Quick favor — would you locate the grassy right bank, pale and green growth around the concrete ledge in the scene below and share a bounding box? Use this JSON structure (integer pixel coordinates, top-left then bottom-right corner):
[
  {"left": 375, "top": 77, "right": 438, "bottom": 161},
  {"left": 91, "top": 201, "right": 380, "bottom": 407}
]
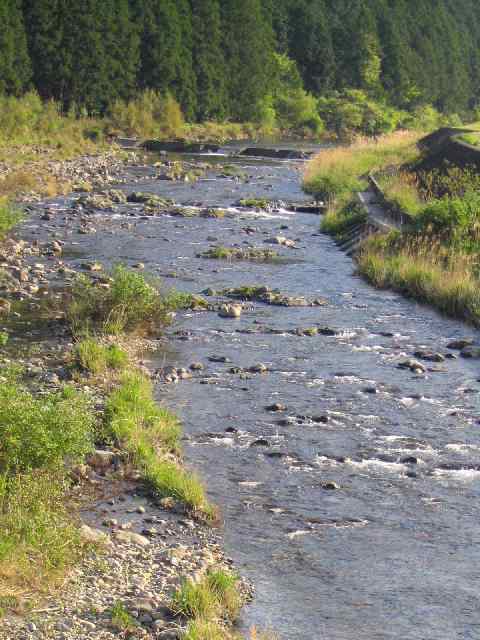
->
[{"left": 305, "top": 127, "right": 480, "bottom": 325}]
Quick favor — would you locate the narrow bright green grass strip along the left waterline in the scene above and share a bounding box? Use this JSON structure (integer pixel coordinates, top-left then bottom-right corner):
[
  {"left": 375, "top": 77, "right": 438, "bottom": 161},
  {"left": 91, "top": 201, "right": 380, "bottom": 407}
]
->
[{"left": 105, "top": 373, "right": 215, "bottom": 518}]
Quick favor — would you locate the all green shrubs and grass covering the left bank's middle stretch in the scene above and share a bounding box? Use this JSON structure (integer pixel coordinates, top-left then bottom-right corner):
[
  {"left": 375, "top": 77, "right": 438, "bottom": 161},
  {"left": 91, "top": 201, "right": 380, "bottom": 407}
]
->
[{"left": 0, "top": 267, "right": 215, "bottom": 613}]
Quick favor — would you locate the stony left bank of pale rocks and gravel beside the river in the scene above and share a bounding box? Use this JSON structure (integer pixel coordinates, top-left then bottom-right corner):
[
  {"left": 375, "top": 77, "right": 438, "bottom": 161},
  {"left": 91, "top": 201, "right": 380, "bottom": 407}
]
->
[{"left": 0, "top": 152, "right": 266, "bottom": 640}]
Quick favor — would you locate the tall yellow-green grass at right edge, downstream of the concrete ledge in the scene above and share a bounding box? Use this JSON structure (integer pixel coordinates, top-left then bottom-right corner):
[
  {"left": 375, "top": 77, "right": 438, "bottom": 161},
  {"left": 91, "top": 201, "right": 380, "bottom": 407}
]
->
[{"left": 358, "top": 236, "right": 480, "bottom": 326}]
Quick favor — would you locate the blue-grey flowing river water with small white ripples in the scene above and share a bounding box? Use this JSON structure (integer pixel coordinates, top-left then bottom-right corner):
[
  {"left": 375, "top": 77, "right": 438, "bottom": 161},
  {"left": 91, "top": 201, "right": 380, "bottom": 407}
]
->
[{"left": 28, "top": 146, "right": 480, "bottom": 640}]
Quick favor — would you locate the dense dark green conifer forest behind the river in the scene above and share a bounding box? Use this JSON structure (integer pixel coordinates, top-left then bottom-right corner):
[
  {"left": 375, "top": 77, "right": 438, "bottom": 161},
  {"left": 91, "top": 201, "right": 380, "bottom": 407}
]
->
[{"left": 0, "top": 0, "right": 480, "bottom": 120}]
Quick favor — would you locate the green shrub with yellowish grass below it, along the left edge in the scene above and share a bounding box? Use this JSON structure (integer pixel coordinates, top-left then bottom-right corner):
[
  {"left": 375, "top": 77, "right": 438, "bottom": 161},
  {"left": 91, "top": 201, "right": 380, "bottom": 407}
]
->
[{"left": 0, "top": 370, "right": 95, "bottom": 598}]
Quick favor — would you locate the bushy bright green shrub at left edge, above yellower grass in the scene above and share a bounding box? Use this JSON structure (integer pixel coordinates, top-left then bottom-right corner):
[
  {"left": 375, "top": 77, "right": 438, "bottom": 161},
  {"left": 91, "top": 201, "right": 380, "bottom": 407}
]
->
[{"left": 0, "top": 380, "right": 94, "bottom": 474}]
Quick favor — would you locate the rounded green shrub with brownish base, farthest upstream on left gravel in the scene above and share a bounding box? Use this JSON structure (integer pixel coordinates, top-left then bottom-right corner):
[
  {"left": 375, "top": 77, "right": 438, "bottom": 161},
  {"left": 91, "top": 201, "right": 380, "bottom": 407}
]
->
[{"left": 67, "top": 266, "right": 171, "bottom": 335}]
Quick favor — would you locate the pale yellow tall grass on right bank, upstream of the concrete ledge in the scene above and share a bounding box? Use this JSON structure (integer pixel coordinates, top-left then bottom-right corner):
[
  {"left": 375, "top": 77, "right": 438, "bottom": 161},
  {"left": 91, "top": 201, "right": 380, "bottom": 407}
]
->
[{"left": 303, "top": 131, "right": 420, "bottom": 206}]
